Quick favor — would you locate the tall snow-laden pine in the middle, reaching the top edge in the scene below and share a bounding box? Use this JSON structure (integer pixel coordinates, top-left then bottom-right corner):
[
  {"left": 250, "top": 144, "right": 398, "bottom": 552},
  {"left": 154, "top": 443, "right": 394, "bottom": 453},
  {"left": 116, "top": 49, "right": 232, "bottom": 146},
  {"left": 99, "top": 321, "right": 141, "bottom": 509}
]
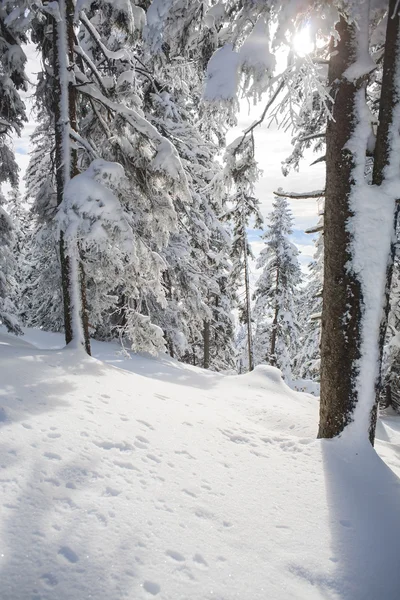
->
[{"left": 138, "top": 1, "right": 234, "bottom": 369}]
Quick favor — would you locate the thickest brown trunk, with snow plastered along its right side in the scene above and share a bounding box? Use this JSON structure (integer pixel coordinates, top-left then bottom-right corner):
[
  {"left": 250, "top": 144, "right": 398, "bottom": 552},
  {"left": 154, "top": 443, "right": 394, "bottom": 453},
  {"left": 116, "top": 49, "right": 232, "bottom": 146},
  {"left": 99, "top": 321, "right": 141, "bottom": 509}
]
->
[{"left": 318, "top": 17, "right": 363, "bottom": 438}]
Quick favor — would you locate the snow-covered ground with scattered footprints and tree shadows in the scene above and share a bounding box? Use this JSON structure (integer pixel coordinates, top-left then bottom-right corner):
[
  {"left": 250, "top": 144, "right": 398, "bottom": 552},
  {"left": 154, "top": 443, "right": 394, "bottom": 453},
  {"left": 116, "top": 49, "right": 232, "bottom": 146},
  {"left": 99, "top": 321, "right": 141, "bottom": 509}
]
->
[{"left": 0, "top": 331, "right": 400, "bottom": 600}]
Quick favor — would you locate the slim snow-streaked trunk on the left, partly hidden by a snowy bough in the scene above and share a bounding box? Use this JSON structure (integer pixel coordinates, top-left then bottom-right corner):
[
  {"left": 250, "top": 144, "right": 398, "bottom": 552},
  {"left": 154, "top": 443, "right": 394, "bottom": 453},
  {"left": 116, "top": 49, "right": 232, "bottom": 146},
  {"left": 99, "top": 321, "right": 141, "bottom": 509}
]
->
[{"left": 53, "top": 0, "right": 90, "bottom": 354}]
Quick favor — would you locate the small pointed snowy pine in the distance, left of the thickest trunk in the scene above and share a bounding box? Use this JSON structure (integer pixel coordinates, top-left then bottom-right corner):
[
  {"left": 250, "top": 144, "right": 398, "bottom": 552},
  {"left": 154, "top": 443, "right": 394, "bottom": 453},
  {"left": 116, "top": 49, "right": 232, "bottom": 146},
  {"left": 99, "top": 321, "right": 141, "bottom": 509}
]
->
[{"left": 253, "top": 197, "right": 301, "bottom": 380}]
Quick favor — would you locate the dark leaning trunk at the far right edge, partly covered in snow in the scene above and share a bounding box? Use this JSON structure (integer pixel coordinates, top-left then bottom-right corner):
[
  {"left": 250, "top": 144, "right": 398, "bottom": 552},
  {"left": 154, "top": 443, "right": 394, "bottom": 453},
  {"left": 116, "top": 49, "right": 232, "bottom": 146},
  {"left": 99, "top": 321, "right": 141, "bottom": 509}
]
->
[{"left": 370, "top": 0, "right": 400, "bottom": 443}]
